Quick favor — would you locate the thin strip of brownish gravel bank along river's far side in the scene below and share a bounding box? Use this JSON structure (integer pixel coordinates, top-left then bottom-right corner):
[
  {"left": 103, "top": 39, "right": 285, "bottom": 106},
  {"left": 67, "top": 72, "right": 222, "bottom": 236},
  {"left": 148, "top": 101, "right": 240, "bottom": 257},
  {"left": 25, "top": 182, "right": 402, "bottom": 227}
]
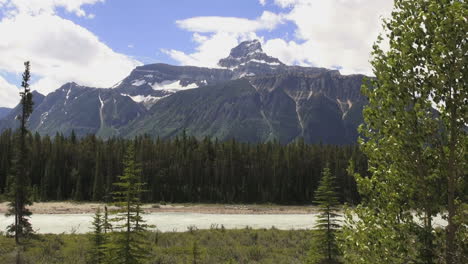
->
[{"left": 0, "top": 202, "right": 317, "bottom": 215}]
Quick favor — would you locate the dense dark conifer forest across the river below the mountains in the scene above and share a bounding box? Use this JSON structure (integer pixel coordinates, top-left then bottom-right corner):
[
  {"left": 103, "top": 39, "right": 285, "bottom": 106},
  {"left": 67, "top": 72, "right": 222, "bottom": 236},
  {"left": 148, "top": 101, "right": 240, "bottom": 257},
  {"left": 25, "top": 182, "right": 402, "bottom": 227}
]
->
[{"left": 0, "top": 130, "right": 367, "bottom": 204}]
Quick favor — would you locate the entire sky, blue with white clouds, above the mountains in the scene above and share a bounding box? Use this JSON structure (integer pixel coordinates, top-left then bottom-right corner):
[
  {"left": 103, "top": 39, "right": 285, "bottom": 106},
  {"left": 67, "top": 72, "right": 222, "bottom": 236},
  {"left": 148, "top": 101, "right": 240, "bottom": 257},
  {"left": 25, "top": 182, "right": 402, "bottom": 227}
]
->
[{"left": 0, "top": 0, "right": 393, "bottom": 107}]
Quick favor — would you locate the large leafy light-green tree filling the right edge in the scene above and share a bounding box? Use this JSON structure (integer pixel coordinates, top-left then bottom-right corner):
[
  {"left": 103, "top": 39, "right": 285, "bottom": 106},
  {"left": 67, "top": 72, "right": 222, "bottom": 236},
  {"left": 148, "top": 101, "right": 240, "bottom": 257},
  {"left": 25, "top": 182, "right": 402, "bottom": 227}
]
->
[{"left": 343, "top": 0, "right": 468, "bottom": 264}]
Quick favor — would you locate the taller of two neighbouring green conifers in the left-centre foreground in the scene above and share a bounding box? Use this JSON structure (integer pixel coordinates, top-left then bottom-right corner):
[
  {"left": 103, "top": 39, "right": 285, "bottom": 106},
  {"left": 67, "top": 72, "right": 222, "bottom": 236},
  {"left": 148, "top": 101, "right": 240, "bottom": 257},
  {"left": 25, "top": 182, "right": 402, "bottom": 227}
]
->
[{"left": 108, "top": 144, "right": 147, "bottom": 264}]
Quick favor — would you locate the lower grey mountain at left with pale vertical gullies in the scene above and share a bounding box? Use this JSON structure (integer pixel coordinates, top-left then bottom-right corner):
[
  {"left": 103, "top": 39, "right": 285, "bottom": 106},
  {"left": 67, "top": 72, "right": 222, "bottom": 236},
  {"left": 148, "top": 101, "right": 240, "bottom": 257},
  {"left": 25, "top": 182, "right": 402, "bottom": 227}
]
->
[{"left": 0, "top": 83, "right": 146, "bottom": 138}]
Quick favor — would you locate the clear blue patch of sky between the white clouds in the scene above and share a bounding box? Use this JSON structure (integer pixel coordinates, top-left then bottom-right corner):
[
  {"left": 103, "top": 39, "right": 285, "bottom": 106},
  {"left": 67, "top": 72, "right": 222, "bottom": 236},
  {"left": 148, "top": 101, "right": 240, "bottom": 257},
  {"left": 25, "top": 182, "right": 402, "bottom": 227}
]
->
[{"left": 58, "top": 0, "right": 294, "bottom": 64}]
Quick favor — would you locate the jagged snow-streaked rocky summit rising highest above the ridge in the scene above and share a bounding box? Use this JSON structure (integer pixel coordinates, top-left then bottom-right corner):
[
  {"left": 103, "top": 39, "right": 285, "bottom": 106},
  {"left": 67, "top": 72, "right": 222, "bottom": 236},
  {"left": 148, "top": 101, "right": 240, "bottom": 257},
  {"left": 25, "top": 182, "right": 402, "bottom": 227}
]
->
[{"left": 218, "top": 40, "right": 284, "bottom": 69}]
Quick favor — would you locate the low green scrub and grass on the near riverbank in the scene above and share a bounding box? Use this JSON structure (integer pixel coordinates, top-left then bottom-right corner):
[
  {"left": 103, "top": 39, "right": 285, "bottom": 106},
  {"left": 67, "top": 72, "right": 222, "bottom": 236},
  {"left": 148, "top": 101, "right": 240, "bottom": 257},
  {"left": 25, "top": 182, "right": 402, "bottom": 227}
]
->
[{"left": 0, "top": 228, "right": 312, "bottom": 264}]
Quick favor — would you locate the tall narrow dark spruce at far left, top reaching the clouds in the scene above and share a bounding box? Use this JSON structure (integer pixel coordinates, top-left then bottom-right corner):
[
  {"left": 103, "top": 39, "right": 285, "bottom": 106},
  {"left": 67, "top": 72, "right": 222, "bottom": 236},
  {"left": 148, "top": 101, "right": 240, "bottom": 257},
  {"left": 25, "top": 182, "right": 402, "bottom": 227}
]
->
[{"left": 7, "top": 61, "right": 33, "bottom": 244}]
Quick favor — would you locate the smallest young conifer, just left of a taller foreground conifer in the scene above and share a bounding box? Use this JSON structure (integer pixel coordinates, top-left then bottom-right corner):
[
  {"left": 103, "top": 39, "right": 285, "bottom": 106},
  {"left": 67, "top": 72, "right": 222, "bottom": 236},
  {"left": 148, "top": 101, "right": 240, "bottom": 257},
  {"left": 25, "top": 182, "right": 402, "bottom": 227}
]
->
[{"left": 89, "top": 208, "right": 106, "bottom": 264}]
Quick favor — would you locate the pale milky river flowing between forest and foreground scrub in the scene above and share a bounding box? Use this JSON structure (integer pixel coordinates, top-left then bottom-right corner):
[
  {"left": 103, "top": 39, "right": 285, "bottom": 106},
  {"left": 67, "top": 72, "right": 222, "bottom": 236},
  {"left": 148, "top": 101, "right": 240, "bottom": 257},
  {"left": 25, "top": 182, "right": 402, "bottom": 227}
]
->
[{"left": 0, "top": 212, "right": 446, "bottom": 234}]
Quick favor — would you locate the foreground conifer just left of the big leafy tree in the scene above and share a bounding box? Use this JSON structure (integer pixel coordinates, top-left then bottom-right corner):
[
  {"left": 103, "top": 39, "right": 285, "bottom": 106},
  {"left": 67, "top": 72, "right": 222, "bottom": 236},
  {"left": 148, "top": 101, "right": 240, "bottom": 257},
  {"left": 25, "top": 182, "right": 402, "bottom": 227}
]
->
[{"left": 308, "top": 167, "right": 340, "bottom": 264}]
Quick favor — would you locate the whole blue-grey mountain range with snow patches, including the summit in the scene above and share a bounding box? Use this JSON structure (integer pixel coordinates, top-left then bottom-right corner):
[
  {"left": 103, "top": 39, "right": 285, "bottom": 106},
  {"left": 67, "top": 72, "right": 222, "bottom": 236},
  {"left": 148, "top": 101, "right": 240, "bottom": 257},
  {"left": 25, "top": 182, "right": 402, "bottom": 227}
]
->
[{"left": 0, "top": 40, "right": 365, "bottom": 144}]
